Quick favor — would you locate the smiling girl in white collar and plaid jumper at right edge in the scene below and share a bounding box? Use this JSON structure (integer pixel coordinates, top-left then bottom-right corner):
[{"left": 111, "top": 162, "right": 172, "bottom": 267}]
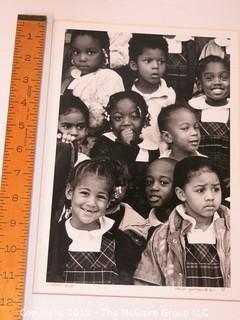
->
[{"left": 189, "top": 55, "right": 230, "bottom": 185}]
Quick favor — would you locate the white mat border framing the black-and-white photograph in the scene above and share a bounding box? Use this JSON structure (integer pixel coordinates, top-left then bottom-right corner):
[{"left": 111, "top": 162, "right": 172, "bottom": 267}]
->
[{"left": 33, "top": 21, "right": 240, "bottom": 300}]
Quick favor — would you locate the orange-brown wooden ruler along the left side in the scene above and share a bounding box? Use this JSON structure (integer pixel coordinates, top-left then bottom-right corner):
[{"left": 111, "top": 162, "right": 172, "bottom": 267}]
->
[{"left": 0, "top": 15, "right": 46, "bottom": 320}]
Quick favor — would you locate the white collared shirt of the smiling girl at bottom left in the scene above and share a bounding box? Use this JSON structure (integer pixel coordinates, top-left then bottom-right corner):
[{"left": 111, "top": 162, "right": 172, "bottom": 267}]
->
[{"left": 65, "top": 216, "right": 114, "bottom": 252}]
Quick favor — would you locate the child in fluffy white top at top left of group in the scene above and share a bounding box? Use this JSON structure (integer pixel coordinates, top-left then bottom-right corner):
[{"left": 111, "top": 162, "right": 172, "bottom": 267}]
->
[{"left": 62, "top": 30, "right": 124, "bottom": 135}]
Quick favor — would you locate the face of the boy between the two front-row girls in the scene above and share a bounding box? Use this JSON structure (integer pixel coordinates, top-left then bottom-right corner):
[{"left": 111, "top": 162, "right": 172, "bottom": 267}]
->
[{"left": 145, "top": 159, "right": 174, "bottom": 208}]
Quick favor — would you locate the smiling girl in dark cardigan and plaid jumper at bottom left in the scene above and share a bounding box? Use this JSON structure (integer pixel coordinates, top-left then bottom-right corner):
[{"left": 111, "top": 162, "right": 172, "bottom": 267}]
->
[{"left": 47, "top": 159, "right": 144, "bottom": 284}]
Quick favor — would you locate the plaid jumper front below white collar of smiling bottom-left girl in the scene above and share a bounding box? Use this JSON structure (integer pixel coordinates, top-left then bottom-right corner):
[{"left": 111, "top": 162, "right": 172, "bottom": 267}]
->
[{"left": 64, "top": 236, "right": 118, "bottom": 284}]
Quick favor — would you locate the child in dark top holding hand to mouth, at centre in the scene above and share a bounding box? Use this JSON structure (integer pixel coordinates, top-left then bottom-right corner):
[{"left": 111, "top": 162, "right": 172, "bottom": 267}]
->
[{"left": 90, "top": 91, "right": 159, "bottom": 216}]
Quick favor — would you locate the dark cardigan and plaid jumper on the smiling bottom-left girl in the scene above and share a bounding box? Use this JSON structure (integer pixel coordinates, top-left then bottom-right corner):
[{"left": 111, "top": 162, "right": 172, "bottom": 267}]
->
[{"left": 46, "top": 220, "right": 144, "bottom": 284}]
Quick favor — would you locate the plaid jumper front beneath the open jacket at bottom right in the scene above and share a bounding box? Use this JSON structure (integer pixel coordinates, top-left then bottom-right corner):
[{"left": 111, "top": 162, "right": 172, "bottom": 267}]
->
[{"left": 186, "top": 243, "right": 223, "bottom": 287}]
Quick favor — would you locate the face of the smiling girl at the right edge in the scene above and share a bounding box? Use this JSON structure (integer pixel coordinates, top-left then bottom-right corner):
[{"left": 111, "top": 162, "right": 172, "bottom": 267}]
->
[{"left": 201, "top": 62, "right": 230, "bottom": 105}]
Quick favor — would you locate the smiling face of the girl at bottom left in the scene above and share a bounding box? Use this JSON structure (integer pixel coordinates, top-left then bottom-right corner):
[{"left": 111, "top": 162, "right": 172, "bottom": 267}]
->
[{"left": 66, "top": 173, "right": 109, "bottom": 230}]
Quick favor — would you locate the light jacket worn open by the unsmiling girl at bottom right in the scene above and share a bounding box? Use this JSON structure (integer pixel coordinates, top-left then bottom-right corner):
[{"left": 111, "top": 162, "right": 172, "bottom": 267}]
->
[{"left": 134, "top": 205, "right": 230, "bottom": 287}]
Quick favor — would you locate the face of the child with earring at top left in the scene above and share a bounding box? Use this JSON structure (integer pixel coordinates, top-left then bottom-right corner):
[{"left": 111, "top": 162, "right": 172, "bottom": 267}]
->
[{"left": 72, "top": 35, "right": 103, "bottom": 75}]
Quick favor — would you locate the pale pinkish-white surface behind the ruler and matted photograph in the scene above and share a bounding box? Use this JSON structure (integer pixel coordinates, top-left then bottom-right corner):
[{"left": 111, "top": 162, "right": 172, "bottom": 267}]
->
[{"left": 0, "top": 0, "right": 240, "bottom": 320}]
